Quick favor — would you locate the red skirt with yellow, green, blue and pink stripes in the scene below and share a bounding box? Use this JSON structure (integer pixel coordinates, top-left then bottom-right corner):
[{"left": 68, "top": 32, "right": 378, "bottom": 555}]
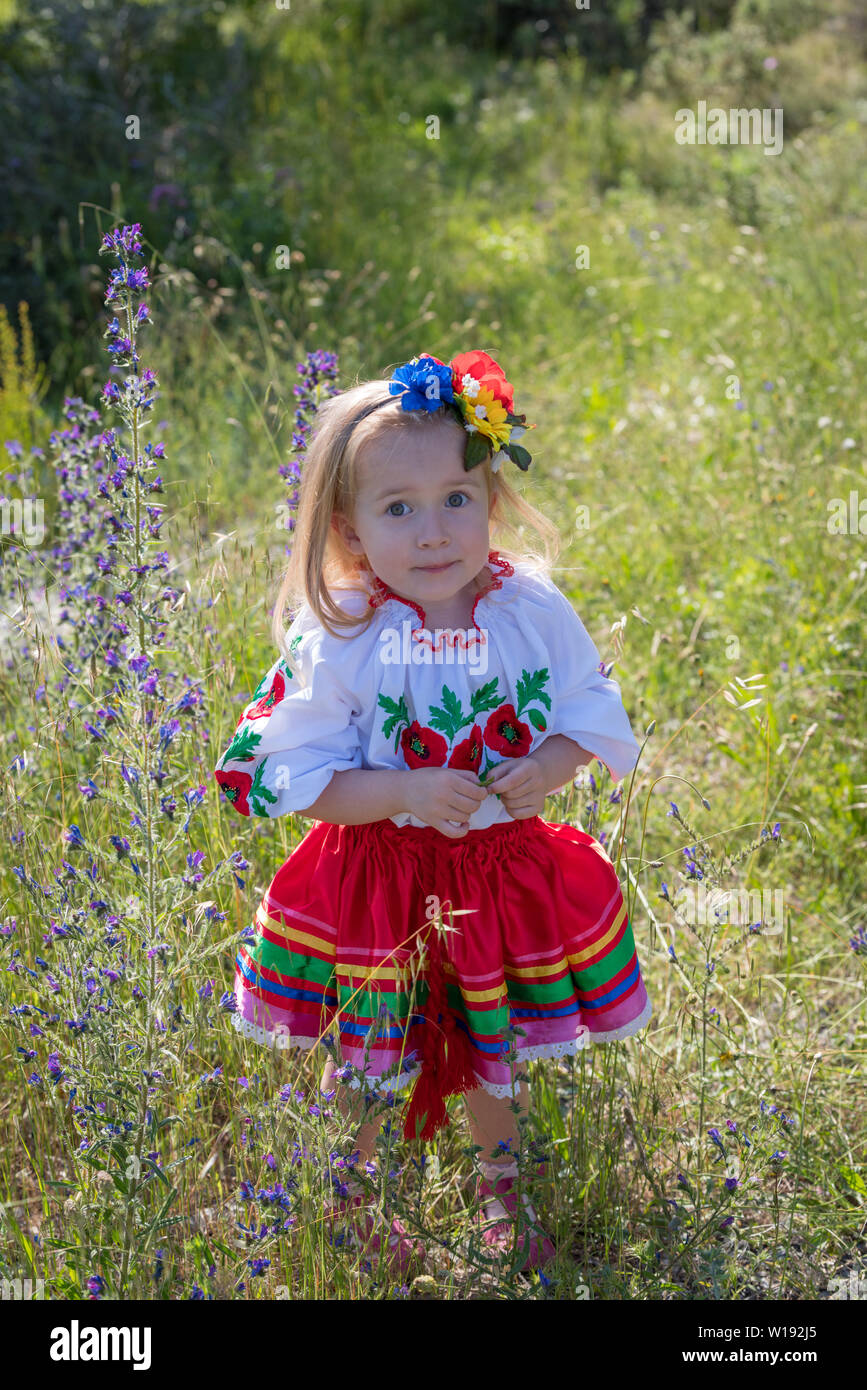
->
[{"left": 231, "top": 816, "right": 652, "bottom": 1138}]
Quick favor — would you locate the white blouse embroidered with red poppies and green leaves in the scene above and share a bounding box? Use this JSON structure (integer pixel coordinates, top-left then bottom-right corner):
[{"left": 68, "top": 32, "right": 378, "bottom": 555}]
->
[{"left": 214, "top": 550, "right": 639, "bottom": 830}]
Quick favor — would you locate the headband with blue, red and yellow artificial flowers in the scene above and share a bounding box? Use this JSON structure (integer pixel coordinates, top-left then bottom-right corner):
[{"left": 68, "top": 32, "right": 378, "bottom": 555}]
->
[{"left": 345, "top": 350, "right": 536, "bottom": 473}]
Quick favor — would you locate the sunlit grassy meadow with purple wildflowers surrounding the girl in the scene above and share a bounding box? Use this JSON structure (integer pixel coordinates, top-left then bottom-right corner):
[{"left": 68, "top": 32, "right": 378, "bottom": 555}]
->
[{"left": 0, "top": 0, "right": 867, "bottom": 1301}]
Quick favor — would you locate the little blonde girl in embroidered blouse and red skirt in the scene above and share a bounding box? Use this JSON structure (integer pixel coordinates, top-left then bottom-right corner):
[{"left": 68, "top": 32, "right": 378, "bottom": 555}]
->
[{"left": 214, "top": 352, "right": 652, "bottom": 1265}]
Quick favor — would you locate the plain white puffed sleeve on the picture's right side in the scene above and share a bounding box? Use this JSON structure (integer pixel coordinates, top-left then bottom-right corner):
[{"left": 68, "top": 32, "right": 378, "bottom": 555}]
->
[{"left": 549, "top": 584, "right": 641, "bottom": 781}]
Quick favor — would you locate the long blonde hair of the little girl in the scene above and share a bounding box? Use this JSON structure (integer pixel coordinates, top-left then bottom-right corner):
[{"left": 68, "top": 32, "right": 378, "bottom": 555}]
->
[{"left": 271, "top": 378, "right": 561, "bottom": 659}]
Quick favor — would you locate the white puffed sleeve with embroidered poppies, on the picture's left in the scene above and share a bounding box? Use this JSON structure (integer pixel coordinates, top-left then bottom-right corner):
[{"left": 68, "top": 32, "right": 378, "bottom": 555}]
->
[{"left": 214, "top": 606, "right": 363, "bottom": 817}]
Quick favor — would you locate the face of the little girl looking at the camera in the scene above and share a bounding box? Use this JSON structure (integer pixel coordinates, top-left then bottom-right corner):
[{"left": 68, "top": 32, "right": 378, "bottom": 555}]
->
[{"left": 332, "top": 427, "right": 495, "bottom": 607}]
